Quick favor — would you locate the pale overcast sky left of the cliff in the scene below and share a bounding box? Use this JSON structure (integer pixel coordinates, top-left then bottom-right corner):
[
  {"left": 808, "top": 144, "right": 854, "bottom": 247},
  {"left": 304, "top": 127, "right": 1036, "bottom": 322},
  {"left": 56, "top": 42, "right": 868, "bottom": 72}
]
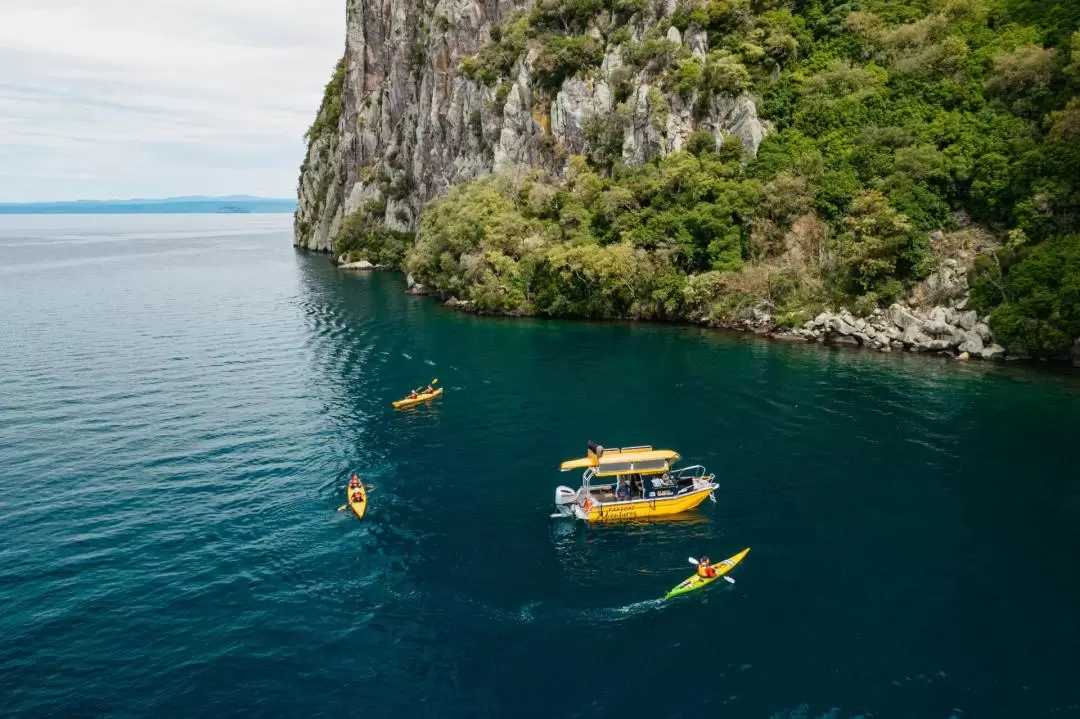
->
[{"left": 0, "top": 0, "right": 345, "bottom": 202}]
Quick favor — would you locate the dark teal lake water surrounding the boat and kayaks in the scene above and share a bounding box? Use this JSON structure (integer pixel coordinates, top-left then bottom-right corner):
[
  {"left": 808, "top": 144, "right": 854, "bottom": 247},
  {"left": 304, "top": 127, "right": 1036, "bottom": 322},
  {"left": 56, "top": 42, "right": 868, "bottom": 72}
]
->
[{"left": 0, "top": 215, "right": 1080, "bottom": 719}]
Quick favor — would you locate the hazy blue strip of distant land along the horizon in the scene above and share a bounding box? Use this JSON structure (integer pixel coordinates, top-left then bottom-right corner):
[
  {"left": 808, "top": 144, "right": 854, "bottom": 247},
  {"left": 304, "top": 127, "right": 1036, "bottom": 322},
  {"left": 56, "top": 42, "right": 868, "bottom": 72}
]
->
[{"left": 0, "top": 194, "right": 296, "bottom": 215}]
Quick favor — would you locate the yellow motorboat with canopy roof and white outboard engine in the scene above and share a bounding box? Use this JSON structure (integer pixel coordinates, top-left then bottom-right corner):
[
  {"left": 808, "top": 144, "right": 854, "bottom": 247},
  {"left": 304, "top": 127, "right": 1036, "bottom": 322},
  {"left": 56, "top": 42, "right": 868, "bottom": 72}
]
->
[{"left": 552, "top": 442, "right": 719, "bottom": 523}]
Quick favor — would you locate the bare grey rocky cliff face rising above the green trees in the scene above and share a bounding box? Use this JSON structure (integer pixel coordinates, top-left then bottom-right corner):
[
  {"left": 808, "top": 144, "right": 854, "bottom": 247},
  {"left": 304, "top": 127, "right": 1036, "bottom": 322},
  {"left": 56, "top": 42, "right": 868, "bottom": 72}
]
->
[{"left": 295, "top": 0, "right": 766, "bottom": 250}]
